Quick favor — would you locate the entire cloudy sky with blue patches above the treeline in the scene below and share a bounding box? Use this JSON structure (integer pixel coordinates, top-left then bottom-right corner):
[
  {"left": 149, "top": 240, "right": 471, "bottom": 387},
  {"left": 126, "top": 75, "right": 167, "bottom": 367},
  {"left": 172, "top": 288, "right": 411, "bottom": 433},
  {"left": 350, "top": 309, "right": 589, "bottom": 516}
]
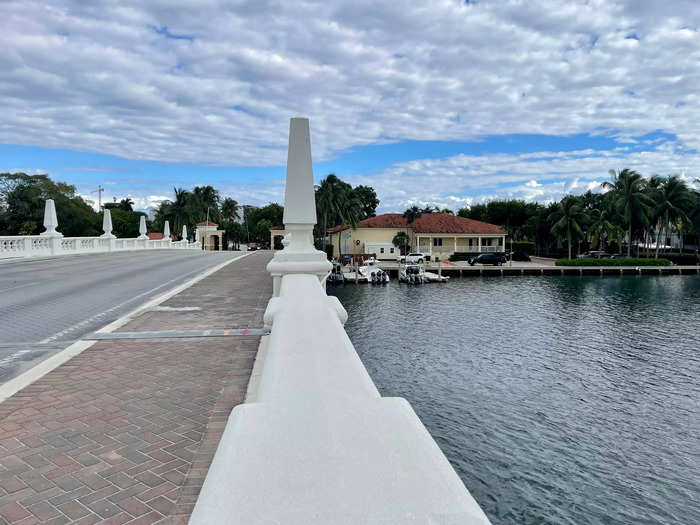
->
[{"left": 0, "top": 0, "right": 700, "bottom": 211}]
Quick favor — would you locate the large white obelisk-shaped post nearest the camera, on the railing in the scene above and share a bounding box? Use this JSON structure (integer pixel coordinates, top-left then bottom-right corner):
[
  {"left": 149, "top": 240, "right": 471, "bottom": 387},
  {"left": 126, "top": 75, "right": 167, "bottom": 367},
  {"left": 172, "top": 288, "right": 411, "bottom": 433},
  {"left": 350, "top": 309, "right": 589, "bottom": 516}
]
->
[{"left": 267, "top": 118, "right": 332, "bottom": 297}]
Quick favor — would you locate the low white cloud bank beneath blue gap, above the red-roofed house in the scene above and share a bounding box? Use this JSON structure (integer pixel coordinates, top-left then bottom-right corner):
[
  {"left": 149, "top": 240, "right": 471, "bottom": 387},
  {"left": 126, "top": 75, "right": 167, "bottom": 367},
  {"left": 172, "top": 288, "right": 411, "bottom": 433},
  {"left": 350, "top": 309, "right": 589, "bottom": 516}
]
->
[{"left": 344, "top": 142, "right": 700, "bottom": 211}]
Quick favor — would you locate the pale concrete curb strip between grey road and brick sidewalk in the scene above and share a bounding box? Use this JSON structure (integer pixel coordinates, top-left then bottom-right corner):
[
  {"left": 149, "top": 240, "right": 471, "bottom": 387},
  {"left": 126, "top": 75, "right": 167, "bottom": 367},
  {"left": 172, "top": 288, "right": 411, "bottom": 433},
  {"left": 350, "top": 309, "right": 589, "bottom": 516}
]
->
[{"left": 0, "top": 252, "right": 256, "bottom": 403}]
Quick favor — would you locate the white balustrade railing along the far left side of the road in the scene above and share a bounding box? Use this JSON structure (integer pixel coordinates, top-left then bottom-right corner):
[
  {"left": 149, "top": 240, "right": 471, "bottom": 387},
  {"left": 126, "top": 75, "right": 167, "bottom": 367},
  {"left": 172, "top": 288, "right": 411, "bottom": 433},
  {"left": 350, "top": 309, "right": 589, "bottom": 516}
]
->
[{"left": 0, "top": 235, "right": 201, "bottom": 259}]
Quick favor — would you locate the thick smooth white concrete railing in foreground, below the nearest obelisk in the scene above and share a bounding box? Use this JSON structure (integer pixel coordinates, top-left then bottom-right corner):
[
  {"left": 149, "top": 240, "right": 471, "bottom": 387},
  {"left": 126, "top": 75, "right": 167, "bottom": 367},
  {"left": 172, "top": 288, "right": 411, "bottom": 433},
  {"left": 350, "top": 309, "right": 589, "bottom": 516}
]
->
[{"left": 190, "top": 274, "right": 489, "bottom": 525}]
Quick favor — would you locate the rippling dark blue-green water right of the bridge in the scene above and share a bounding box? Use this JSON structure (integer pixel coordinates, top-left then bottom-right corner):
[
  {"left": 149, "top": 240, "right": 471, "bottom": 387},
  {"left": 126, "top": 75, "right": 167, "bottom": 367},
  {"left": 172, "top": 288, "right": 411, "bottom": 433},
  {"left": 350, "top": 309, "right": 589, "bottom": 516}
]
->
[{"left": 328, "top": 276, "right": 700, "bottom": 525}]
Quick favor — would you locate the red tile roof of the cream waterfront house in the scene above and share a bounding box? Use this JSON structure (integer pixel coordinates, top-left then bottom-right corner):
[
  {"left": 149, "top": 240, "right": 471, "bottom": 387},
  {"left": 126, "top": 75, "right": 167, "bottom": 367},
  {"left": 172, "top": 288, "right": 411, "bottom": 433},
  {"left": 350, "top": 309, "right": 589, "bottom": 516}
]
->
[{"left": 329, "top": 213, "right": 506, "bottom": 235}]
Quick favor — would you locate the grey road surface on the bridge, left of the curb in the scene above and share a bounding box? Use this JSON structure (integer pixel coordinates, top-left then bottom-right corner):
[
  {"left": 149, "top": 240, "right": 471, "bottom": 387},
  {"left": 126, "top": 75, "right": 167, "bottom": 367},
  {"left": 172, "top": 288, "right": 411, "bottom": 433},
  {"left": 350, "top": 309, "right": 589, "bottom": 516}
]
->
[{"left": 0, "top": 250, "right": 241, "bottom": 384}]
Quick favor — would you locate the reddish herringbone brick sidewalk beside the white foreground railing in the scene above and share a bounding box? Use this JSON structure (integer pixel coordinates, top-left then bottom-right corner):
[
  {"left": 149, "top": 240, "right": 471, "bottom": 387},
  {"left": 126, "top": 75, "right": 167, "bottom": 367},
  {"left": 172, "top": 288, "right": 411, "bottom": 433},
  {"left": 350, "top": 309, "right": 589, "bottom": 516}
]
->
[{"left": 0, "top": 252, "right": 272, "bottom": 525}]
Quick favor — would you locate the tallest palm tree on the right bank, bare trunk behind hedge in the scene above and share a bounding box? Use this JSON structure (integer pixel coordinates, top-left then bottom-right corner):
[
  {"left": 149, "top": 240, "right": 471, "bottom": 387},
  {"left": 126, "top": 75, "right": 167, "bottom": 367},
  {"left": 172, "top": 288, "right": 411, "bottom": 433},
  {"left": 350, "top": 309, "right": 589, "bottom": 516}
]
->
[{"left": 602, "top": 168, "right": 652, "bottom": 257}]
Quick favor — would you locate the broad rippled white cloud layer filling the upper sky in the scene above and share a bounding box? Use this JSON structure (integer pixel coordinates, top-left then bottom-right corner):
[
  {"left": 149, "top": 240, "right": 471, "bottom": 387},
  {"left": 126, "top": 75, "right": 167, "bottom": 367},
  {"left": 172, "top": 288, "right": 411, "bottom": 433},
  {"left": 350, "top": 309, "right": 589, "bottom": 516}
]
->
[{"left": 0, "top": 0, "right": 700, "bottom": 166}]
